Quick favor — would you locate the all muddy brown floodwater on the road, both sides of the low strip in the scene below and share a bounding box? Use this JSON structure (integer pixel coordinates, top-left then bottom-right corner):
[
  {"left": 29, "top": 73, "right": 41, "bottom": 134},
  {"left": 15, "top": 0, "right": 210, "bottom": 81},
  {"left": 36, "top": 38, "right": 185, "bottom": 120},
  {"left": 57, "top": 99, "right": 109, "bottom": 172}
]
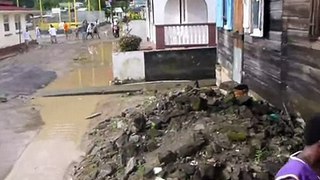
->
[{"left": 6, "top": 42, "right": 113, "bottom": 180}]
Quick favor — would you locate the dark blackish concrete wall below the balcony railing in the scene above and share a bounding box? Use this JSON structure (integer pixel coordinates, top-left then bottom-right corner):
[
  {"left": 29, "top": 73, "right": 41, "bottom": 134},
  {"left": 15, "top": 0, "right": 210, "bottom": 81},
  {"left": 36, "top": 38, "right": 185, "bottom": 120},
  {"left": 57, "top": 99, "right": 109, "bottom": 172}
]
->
[{"left": 144, "top": 48, "right": 216, "bottom": 81}]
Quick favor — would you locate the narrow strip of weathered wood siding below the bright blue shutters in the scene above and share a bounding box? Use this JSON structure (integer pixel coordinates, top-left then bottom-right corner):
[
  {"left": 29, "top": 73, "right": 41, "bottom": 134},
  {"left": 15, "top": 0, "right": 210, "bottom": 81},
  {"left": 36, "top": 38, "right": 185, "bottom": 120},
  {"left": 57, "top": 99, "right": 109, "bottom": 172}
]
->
[{"left": 217, "top": 28, "right": 233, "bottom": 78}]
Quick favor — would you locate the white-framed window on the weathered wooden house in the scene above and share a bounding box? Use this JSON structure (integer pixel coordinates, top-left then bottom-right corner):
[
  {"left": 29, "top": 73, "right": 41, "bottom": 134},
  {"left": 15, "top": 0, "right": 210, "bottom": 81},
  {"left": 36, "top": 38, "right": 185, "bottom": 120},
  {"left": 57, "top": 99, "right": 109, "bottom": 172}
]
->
[{"left": 243, "top": 0, "right": 264, "bottom": 37}]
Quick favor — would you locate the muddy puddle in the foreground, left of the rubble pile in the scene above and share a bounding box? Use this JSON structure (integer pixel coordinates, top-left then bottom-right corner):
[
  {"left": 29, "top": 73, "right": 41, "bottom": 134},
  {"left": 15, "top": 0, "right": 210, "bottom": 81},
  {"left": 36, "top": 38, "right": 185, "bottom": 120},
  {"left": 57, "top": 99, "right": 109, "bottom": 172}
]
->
[{"left": 6, "top": 96, "right": 107, "bottom": 180}]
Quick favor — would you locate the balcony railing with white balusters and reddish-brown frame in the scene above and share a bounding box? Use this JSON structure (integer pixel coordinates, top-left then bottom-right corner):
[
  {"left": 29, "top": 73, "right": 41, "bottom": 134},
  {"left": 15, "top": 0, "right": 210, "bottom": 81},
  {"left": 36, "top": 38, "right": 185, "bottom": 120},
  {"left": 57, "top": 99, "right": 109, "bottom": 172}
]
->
[{"left": 156, "top": 24, "right": 216, "bottom": 49}]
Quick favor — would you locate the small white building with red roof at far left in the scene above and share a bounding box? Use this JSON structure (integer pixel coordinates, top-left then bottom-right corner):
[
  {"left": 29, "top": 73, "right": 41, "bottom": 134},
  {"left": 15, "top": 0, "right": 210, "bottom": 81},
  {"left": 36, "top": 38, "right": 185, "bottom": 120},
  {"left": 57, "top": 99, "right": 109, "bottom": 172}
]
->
[{"left": 0, "top": 1, "right": 37, "bottom": 49}]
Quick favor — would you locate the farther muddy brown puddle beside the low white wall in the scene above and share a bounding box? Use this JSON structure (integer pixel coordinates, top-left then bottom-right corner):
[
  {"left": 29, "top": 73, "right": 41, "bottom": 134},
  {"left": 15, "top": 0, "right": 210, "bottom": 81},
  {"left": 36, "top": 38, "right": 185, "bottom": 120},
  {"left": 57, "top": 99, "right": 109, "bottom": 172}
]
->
[{"left": 46, "top": 42, "right": 113, "bottom": 90}]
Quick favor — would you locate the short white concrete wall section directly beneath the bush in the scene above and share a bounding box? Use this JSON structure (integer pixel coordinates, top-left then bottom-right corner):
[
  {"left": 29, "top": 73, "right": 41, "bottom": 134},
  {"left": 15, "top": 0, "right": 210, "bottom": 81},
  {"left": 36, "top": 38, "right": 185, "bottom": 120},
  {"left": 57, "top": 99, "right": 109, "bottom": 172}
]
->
[{"left": 112, "top": 51, "right": 145, "bottom": 80}]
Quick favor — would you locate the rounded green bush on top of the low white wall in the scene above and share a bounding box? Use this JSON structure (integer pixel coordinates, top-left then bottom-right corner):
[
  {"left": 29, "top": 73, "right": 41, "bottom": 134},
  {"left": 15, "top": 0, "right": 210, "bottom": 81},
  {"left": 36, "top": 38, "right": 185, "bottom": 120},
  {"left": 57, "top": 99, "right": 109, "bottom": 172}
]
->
[{"left": 119, "top": 35, "right": 142, "bottom": 52}]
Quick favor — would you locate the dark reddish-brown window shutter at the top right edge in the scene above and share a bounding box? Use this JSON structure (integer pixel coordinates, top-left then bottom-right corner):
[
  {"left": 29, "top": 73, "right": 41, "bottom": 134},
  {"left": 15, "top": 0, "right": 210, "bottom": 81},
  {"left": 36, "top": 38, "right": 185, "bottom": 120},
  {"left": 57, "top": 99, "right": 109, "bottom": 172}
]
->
[{"left": 309, "top": 0, "right": 320, "bottom": 40}]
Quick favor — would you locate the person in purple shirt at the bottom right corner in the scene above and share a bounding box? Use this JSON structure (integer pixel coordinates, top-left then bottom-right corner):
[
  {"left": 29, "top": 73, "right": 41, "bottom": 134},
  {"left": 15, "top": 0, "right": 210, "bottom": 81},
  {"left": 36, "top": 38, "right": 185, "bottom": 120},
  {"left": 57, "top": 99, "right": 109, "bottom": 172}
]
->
[{"left": 275, "top": 114, "right": 320, "bottom": 180}]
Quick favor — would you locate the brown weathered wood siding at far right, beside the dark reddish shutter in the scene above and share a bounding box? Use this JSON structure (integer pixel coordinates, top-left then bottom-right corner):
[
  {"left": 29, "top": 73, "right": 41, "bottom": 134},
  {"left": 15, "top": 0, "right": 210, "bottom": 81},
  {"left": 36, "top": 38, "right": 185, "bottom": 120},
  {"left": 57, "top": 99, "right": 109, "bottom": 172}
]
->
[{"left": 283, "top": 0, "right": 320, "bottom": 118}]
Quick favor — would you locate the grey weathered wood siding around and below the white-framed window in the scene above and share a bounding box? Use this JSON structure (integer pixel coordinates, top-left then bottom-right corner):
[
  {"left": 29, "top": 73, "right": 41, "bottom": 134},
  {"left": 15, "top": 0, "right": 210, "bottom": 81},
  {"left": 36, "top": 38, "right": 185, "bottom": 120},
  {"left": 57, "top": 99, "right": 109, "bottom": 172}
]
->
[{"left": 243, "top": 0, "right": 283, "bottom": 107}]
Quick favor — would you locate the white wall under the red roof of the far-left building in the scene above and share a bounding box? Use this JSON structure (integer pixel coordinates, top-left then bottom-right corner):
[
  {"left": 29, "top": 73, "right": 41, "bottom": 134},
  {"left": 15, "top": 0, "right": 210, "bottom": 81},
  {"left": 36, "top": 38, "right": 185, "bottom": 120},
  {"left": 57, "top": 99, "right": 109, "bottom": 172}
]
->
[{"left": 0, "top": 13, "right": 27, "bottom": 48}]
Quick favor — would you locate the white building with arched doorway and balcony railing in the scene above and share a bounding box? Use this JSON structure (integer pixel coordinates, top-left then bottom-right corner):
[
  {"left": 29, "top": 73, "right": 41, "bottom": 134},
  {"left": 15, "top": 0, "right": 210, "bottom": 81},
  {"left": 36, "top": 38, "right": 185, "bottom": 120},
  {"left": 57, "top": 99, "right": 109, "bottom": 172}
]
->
[{"left": 147, "top": 0, "right": 216, "bottom": 49}]
